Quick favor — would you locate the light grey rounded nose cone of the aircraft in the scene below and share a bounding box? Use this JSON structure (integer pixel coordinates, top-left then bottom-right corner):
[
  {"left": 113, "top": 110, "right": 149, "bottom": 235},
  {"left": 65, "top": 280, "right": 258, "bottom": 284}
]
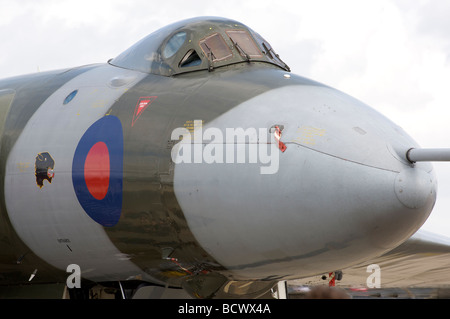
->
[{"left": 174, "top": 82, "right": 435, "bottom": 279}]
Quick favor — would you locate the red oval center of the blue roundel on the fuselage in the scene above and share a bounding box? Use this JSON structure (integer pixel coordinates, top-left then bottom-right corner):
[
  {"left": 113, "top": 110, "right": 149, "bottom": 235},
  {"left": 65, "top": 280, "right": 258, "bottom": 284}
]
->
[{"left": 84, "top": 142, "right": 110, "bottom": 200}]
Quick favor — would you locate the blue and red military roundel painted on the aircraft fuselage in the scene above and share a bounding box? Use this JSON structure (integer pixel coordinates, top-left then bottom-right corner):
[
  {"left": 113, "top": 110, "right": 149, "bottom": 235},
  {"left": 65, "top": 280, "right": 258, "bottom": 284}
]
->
[{"left": 72, "top": 115, "right": 123, "bottom": 227}]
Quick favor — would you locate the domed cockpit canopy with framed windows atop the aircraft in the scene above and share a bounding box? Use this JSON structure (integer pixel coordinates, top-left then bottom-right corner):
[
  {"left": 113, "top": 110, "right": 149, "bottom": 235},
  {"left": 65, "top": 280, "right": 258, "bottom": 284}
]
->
[{"left": 109, "top": 17, "right": 290, "bottom": 76}]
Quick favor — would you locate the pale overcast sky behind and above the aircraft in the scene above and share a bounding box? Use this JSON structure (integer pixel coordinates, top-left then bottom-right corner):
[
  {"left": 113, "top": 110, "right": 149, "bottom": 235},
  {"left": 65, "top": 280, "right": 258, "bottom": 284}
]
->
[{"left": 0, "top": 0, "right": 450, "bottom": 236}]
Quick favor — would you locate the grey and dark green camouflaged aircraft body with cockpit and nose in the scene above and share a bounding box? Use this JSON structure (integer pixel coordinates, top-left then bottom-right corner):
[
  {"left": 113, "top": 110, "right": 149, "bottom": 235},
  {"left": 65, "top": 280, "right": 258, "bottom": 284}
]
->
[{"left": 0, "top": 18, "right": 436, "bottom": 297}]
